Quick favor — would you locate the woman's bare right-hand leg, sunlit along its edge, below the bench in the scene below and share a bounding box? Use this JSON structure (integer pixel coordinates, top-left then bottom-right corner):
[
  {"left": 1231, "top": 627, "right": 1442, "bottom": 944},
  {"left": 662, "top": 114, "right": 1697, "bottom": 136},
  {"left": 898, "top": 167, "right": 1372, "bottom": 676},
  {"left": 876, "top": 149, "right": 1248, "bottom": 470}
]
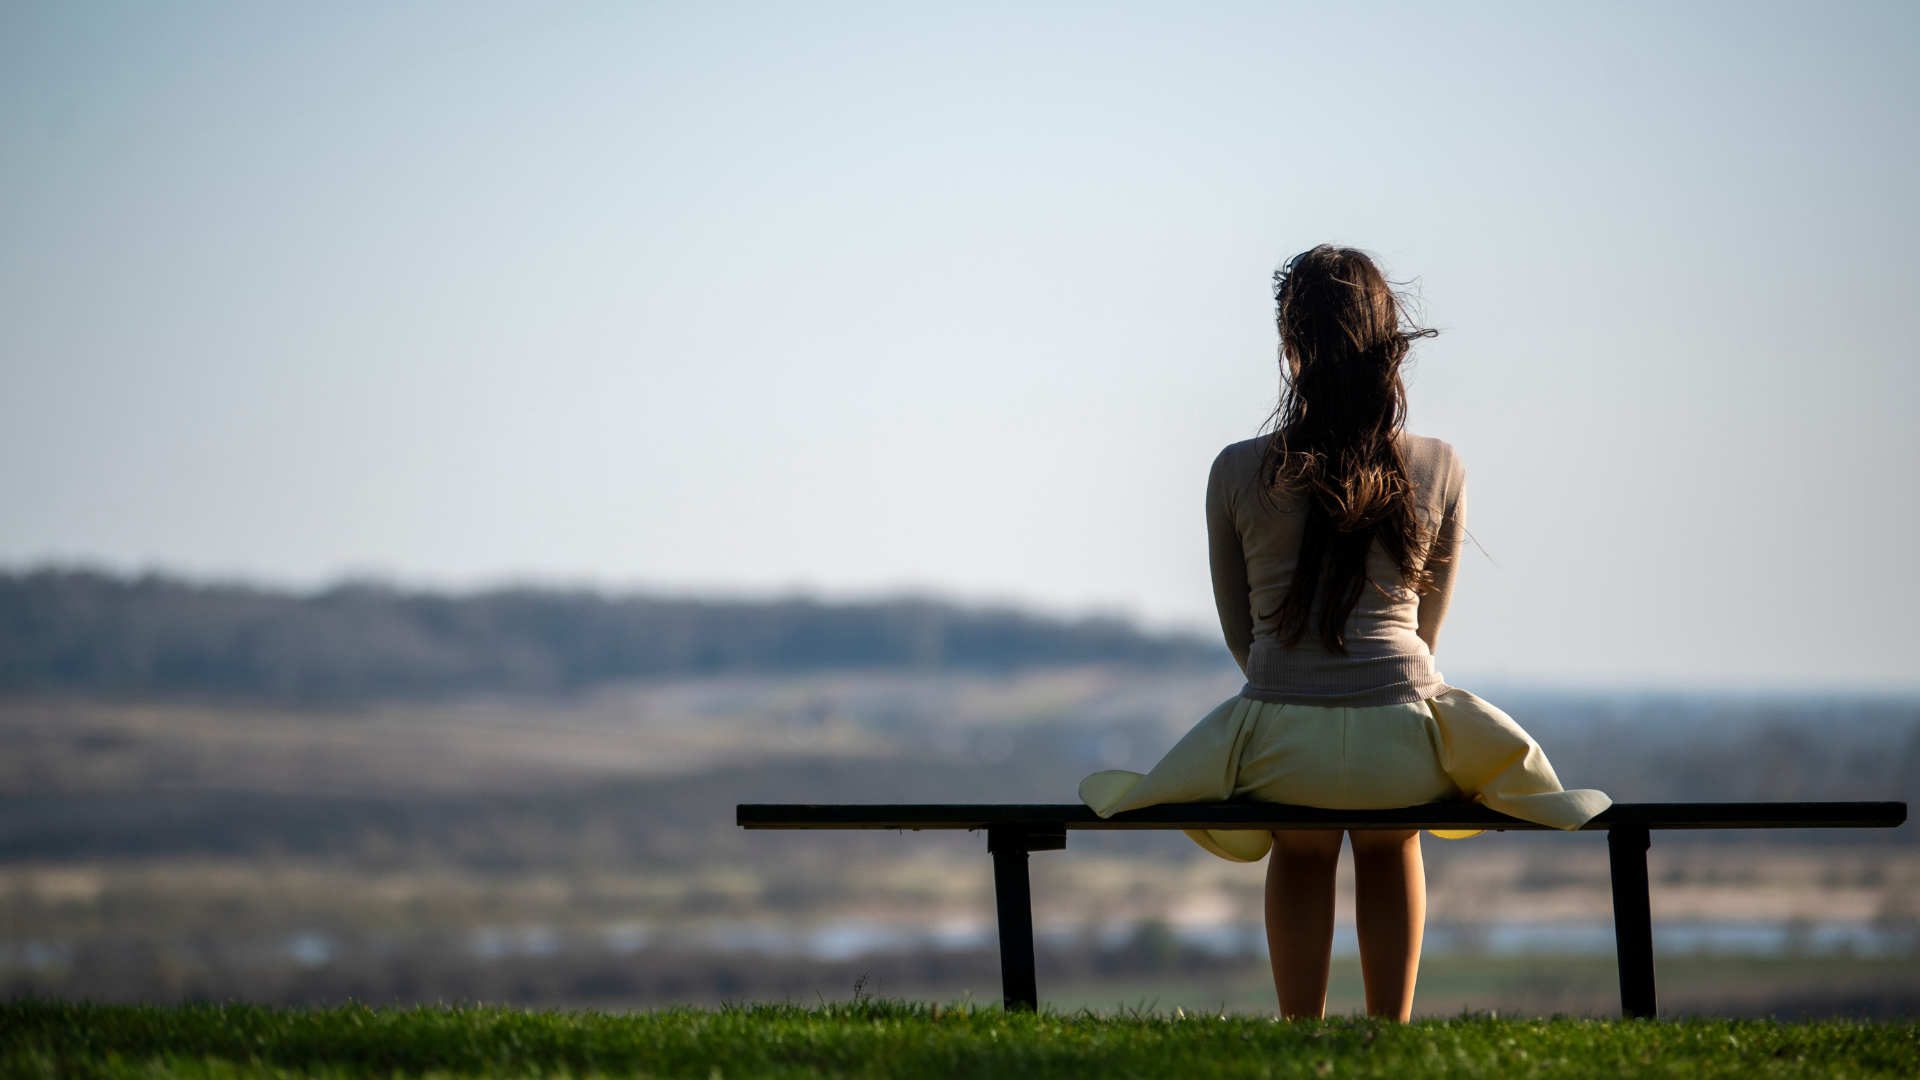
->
[{"left": 1351, "top": 830, "right": 1427, "bottom": 1020}]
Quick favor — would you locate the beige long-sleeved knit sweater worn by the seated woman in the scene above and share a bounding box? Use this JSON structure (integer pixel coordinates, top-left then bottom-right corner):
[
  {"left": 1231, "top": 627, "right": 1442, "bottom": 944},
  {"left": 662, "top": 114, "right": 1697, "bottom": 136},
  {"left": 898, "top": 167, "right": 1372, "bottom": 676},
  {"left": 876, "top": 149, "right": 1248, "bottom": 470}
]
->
[{"left": 1206, "top": 434, "right": 1467, "bottom": 707}]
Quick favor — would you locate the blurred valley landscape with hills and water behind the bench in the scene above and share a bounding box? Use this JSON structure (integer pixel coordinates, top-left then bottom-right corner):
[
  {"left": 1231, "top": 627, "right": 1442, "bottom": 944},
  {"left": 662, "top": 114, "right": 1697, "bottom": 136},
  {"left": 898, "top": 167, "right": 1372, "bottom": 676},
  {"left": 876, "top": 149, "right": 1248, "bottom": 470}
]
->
[{"left": 0, "top": 571, "right": 1920, "bottom": 1017}]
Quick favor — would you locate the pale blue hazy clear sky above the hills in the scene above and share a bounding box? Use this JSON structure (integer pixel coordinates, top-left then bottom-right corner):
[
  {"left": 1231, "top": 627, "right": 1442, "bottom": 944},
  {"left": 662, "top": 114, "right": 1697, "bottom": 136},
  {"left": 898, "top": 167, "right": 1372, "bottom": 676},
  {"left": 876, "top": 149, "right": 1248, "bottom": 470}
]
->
[{"left": 0, "top": 0, "right": 1920, "bottom": 686}]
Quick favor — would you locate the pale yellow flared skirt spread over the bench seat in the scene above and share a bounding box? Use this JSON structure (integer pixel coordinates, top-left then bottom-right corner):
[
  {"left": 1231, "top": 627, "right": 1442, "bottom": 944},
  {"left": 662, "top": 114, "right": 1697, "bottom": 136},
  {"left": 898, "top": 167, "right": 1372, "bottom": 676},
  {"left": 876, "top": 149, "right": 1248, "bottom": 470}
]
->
[{"left": 1079, "top": 690, "right": 1613, "bottom": 863}]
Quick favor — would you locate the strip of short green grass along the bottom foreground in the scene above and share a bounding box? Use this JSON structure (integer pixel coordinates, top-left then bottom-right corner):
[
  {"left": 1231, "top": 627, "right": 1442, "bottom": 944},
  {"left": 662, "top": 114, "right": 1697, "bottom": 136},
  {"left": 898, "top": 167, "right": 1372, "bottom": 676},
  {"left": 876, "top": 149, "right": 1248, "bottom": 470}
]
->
[{"left": 0, "top": 999, "right": 1920, "bottom": 1080}]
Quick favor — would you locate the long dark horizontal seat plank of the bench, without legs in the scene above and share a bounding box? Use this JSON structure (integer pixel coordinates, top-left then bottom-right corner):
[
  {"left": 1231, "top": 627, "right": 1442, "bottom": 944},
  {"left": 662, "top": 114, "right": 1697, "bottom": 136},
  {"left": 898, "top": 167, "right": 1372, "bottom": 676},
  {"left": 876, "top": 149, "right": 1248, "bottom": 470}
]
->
[{"left": 735, "top": 803, "right": 1907, "bottom": 830}]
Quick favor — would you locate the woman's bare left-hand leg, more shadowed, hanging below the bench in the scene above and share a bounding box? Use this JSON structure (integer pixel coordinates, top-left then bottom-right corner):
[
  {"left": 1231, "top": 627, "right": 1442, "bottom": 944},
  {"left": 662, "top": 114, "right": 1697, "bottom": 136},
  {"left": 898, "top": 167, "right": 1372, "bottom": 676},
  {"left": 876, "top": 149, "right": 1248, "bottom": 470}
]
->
[{"left": 1267, "top": 828, "right": 1342, "bottom": 1019}]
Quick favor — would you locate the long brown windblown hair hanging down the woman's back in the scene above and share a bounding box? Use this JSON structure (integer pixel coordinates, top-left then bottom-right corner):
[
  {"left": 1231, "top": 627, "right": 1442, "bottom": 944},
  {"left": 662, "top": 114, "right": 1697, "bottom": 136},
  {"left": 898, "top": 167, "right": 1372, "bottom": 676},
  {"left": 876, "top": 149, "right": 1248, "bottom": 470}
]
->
[{"left": 1261, "top": 244, "right": 1438, "bottom": 655}]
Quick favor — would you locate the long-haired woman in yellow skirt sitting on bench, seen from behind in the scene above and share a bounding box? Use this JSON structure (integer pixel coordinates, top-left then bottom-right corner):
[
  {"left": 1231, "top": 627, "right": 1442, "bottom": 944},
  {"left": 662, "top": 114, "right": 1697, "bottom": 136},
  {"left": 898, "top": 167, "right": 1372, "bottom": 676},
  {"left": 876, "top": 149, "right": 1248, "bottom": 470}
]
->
[{"left": 1081, "top": 246, "right": 1611, "bottom": 1020}]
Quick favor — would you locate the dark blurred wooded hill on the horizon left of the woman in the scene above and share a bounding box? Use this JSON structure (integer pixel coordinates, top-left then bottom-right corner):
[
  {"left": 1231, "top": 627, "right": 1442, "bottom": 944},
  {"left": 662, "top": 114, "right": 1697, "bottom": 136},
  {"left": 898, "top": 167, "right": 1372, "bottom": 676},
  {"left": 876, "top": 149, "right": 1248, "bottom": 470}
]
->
[{"left": 0, "top": 569, "right": 1227, "bottom": 700}]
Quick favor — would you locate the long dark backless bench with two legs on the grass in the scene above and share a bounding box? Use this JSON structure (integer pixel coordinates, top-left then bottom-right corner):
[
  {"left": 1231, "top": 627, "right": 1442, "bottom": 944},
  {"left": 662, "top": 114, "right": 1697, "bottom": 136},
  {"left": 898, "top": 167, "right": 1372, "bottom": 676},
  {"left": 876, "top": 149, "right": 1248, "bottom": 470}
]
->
[{"left": 735, "top": 803, "right": 1907, "bottom": 1019}]
